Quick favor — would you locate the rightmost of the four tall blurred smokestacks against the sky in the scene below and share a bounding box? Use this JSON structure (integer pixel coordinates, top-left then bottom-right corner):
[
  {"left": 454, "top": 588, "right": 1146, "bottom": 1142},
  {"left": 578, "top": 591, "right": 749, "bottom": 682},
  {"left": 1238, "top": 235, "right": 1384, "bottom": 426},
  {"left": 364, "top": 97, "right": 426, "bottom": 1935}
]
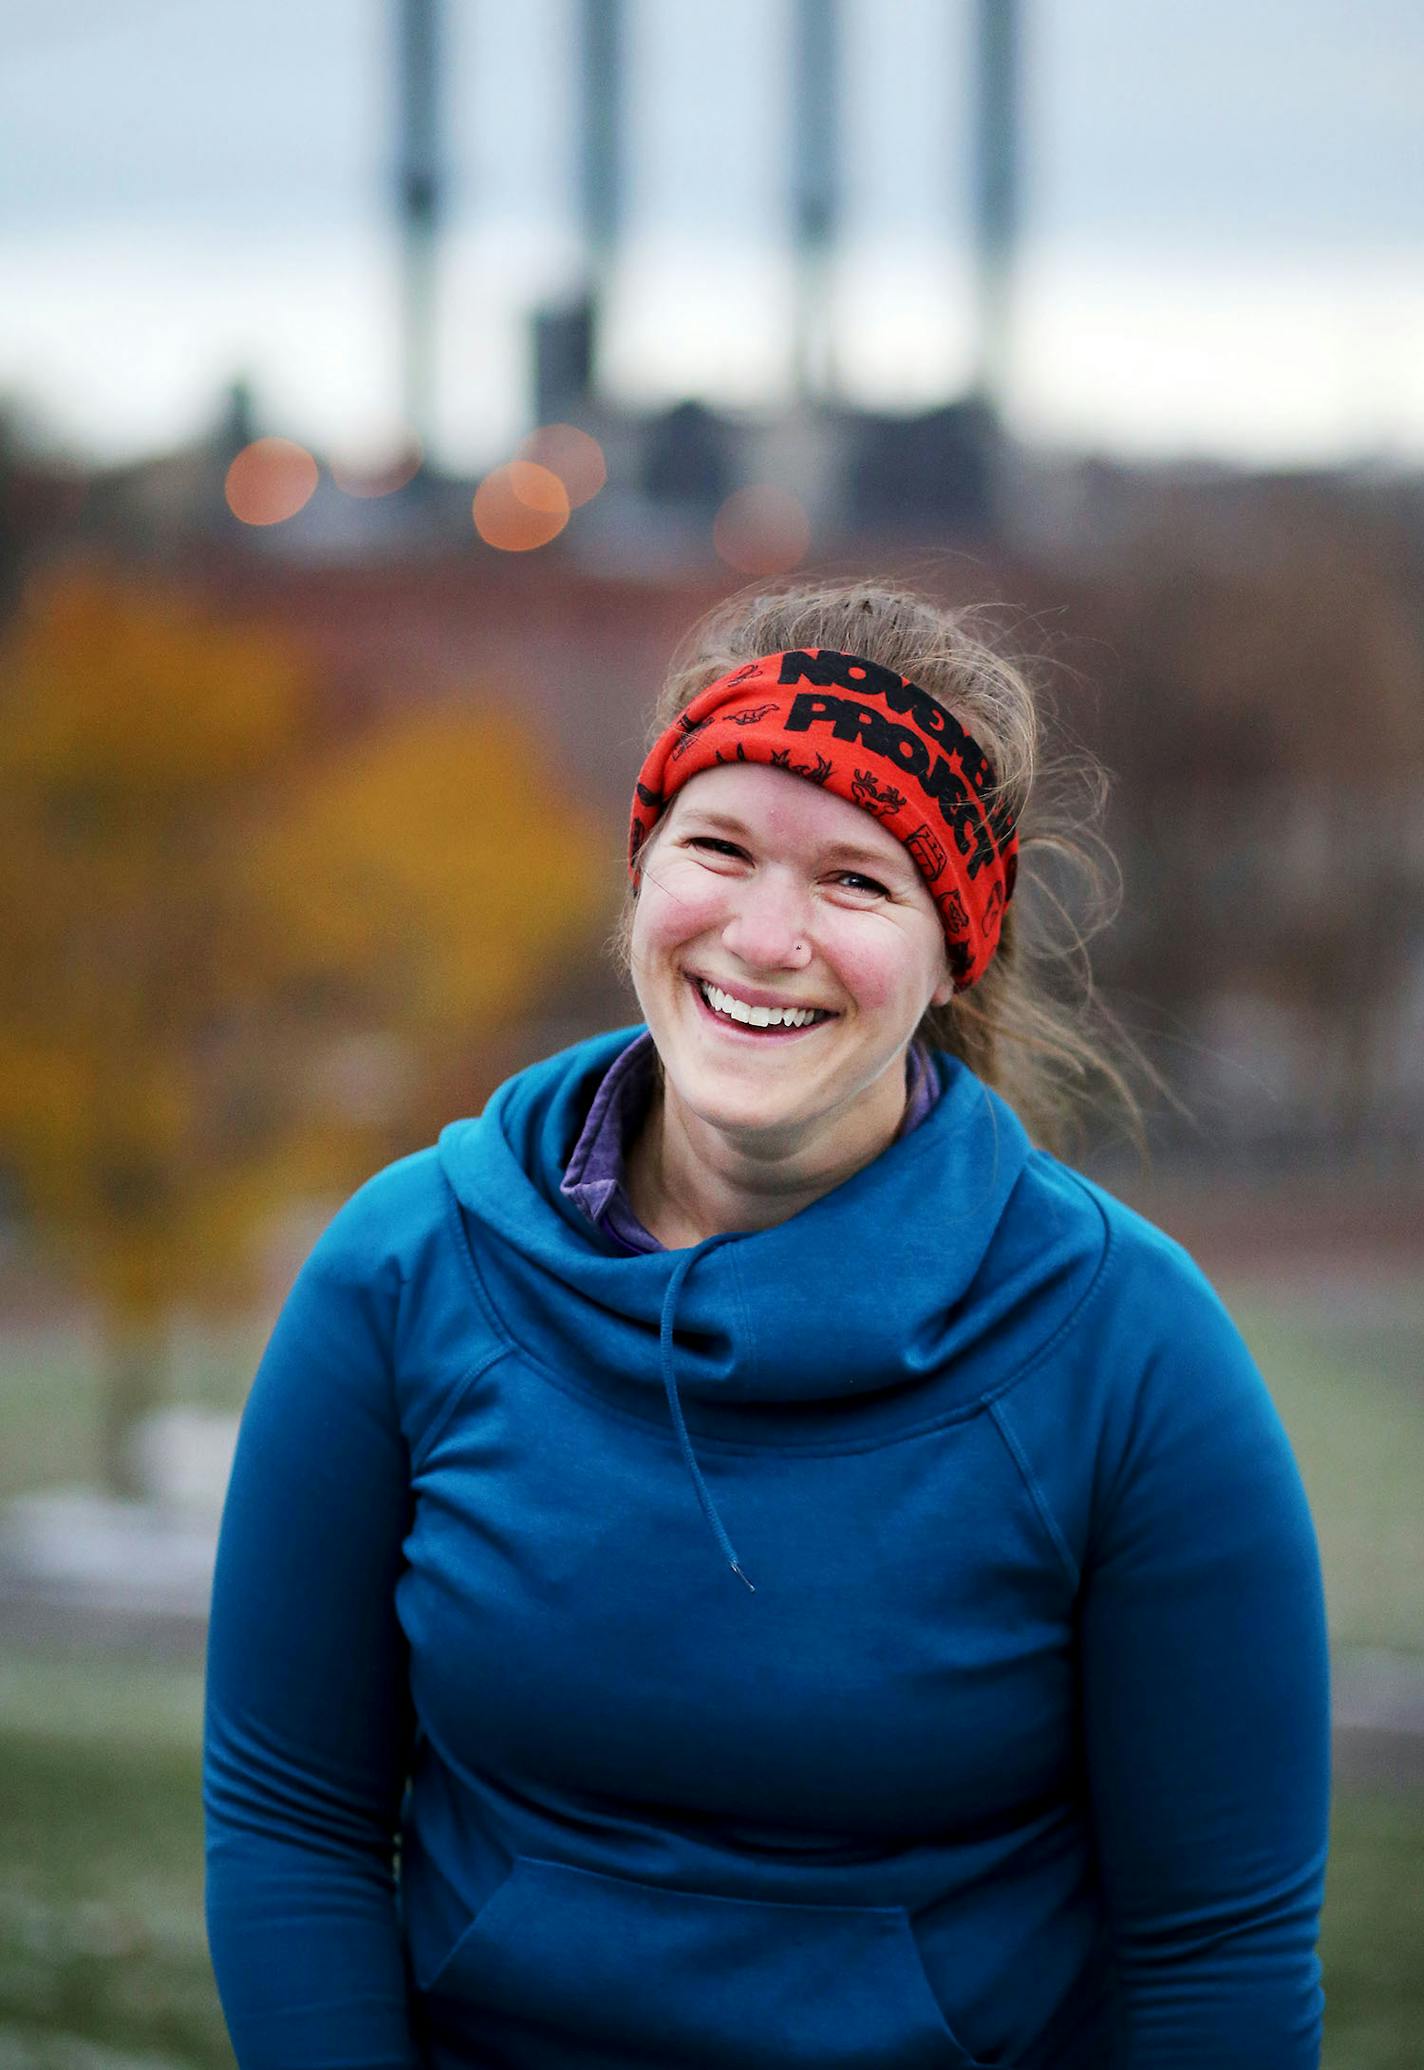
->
[{"left": 973, "top": 0, "right": 1020, "bottom": 410}]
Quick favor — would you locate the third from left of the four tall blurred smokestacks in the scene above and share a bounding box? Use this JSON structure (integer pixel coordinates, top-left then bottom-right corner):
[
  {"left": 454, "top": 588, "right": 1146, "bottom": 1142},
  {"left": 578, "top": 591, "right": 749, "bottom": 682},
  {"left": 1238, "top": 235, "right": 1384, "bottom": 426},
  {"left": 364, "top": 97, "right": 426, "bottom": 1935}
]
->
[{"left": 791, "top": 0, "right": 840, "bottom": 402}]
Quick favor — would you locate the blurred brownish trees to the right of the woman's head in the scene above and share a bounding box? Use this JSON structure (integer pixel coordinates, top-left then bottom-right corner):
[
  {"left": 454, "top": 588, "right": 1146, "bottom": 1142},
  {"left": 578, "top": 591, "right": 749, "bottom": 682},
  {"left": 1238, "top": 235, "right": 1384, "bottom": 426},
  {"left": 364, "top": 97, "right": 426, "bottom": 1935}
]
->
[{"left": 1041, "top": 476, "right": 1424, "bottom": 1184}]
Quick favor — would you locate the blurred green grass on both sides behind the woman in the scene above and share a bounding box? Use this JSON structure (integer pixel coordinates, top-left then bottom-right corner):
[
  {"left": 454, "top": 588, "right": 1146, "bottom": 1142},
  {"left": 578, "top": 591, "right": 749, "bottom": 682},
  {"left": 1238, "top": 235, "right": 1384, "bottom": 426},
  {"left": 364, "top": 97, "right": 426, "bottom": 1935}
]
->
[{"left": 0, "top": 1290, "right": 1424, "bottom": 2070}]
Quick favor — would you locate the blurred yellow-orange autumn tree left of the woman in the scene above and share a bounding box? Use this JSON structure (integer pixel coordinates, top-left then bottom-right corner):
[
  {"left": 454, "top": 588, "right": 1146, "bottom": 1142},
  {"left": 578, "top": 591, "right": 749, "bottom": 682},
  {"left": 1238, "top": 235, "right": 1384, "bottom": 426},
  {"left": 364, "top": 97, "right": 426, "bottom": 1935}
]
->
[{"left": 0, "top": 569, "right": 600, "bottom": 1490}]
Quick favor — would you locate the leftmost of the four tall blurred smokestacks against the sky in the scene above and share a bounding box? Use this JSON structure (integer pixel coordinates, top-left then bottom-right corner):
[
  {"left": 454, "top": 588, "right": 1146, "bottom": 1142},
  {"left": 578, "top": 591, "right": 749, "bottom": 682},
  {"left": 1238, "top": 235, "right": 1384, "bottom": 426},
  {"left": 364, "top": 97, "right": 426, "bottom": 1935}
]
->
[{"left": 395, "top": 0, "right": 443, "bottom": 453}]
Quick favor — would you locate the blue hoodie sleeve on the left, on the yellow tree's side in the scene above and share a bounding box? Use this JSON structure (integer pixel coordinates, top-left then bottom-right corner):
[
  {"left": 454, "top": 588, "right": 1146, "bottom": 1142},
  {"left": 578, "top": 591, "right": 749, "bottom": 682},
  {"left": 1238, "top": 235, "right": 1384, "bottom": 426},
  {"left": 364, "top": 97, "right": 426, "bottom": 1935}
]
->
[{"left": 203, "top": 1196, "right": 418, "bottom": 2070}]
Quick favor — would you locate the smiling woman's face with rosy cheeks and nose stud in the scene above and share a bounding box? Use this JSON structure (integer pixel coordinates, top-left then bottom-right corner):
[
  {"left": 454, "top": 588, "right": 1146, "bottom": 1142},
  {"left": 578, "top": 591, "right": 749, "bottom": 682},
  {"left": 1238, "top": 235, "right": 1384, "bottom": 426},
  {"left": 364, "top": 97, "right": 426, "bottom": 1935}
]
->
[{"left": 631, "top": 762, "right": 954, "bottom": 1153}]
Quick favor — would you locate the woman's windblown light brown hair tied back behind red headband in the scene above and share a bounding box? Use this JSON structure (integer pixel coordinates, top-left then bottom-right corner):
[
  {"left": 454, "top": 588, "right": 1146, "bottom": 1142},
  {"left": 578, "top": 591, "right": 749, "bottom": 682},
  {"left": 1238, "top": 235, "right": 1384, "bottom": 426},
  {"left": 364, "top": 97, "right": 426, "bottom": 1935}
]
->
[{"left": 623, "top": 582, "right": 1159, "bottom": 1151}]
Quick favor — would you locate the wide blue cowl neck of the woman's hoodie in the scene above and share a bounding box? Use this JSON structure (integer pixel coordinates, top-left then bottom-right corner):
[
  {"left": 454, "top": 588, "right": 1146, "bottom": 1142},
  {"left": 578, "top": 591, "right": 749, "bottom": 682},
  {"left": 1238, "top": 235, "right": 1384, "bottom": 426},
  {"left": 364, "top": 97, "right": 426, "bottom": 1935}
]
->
[{"left": 441, "top": 1029, "right": 1101, "bottom": 1403}]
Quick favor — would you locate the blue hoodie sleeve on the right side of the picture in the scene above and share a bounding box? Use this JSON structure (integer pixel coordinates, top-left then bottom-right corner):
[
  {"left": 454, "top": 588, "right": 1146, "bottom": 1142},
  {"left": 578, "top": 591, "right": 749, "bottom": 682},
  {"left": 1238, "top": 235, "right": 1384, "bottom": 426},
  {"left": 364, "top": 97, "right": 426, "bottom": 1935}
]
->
[{"left": 1080, "top": 1277, "right": 1329, "bottom": 2070}]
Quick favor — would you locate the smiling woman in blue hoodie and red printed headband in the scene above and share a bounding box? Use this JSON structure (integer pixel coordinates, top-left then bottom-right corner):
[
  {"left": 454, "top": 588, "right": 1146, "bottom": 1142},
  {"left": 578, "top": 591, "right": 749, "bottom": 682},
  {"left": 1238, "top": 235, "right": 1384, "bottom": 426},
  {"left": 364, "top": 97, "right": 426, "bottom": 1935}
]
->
[{"left": 207, "top": 584, "right": 1329, "bottom": 2070}]
